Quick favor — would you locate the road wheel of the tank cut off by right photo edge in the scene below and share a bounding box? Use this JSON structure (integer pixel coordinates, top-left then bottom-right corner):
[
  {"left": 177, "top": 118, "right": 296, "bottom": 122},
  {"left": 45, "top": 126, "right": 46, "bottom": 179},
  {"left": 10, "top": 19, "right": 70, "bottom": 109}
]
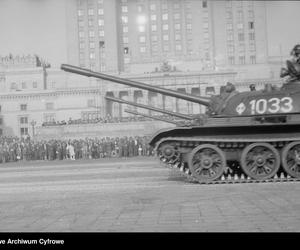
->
[{"left": 281, "top": 141, "right": 300, "bottom": 178}]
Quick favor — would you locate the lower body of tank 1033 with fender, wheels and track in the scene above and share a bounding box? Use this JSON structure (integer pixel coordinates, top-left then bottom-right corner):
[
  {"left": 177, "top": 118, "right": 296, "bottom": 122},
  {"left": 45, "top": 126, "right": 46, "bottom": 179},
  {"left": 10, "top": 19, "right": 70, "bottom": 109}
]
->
[{"left": 154, "top": 122, "right": 300, "bottom": 183}]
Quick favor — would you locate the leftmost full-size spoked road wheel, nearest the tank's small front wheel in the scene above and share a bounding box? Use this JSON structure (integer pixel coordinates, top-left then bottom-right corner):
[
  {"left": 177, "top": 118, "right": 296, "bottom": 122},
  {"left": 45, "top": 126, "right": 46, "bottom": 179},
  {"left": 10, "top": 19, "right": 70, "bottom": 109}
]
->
[{"left": 188, "top": 144, "right": 226, "bottom": 182}]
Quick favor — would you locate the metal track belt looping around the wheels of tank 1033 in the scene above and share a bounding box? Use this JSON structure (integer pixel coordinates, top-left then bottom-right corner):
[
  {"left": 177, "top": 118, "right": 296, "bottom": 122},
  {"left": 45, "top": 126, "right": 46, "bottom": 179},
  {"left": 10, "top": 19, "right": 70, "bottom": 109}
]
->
[{"left": 155, "top": 137, "right": 300, "bottom": 184}]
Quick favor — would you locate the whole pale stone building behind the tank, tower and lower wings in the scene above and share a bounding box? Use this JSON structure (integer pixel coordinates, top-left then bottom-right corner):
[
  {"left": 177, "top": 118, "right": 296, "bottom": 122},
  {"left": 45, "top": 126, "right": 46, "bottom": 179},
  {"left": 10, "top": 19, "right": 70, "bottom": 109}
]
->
[{"left": 0, "top": 0, "right": 283, "bottom": 136}]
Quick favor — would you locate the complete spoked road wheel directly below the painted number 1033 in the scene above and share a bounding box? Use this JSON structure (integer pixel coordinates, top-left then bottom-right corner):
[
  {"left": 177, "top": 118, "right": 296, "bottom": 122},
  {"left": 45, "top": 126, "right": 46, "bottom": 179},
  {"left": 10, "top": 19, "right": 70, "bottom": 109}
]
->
[{"left": 241, "top": 143, "right": 280, "bottom": 180}]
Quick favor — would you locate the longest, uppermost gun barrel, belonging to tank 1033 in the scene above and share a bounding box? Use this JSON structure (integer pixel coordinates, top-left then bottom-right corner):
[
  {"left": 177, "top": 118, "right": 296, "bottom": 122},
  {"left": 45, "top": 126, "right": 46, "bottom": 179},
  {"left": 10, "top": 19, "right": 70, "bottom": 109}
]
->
[{"left": 61, "top": 64, "right": 210, "bottom": 106}]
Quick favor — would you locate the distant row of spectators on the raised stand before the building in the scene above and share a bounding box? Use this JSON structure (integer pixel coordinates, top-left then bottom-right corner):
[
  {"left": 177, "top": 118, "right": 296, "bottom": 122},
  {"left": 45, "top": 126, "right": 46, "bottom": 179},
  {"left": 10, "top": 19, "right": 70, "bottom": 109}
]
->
[{"left": 42, "top": 115, "right": 179, "bottom": 127}]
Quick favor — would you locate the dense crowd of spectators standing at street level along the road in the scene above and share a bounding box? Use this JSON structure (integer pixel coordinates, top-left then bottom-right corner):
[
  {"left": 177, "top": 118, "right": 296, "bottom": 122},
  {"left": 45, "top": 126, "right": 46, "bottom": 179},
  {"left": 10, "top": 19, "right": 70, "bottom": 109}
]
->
[{"left": 0, "top": 136, "right": 153, "bottom": 163}]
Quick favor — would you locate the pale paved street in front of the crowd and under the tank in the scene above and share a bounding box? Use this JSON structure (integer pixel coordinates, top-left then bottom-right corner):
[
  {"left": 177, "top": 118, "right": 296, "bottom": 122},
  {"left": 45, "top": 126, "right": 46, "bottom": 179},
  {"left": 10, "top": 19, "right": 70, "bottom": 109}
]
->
[{"left": 0, "top": 158, "right": 300, "bottom": 232}]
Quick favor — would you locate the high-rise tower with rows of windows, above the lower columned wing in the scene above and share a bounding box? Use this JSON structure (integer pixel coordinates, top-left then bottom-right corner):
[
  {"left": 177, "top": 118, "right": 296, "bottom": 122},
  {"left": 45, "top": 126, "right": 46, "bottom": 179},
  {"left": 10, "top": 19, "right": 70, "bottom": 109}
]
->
[{"left": 67, "top": 0, "right": 268, "bottom": 77}]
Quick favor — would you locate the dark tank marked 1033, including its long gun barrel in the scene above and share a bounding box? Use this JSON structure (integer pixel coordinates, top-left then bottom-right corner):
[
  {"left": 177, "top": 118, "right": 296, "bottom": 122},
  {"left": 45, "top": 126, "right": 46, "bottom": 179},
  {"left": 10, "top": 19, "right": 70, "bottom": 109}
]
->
[{"left": 61, "top": 59, "right": 300, "bottom": 183}]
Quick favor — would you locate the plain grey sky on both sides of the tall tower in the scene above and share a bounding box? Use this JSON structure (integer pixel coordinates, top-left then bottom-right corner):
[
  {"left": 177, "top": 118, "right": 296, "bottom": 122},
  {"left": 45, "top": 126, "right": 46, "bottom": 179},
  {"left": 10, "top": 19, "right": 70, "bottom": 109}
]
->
[{"left": 0, "top": 0, "right": 300, "bottom": 67}]
